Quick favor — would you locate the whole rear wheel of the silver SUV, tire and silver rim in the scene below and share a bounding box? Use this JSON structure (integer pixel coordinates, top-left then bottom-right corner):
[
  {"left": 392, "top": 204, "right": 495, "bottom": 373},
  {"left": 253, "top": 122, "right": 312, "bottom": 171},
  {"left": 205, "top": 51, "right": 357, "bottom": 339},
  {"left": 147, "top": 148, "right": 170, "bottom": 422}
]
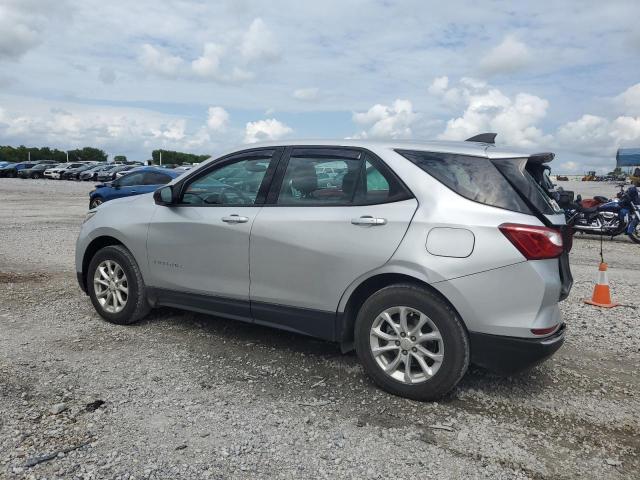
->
[{"left": 355, "top": 284, "right": 470, "bottom": 401}]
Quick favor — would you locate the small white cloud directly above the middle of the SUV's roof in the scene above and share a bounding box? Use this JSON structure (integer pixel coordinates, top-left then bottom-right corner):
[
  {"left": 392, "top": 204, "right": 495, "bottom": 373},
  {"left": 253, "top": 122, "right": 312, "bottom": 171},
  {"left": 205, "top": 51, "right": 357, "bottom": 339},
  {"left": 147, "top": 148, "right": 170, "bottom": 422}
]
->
[{"left": 353, "top": 99, "right": 418, "bottom": 138}]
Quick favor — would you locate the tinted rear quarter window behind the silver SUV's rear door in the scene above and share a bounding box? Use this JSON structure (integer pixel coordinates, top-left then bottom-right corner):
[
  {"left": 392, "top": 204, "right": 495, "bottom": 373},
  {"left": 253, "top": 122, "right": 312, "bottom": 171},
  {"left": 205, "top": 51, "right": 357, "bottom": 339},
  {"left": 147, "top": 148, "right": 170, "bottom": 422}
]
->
[{"left": 396, "top": 150, "right": 531, "bottom": 214}]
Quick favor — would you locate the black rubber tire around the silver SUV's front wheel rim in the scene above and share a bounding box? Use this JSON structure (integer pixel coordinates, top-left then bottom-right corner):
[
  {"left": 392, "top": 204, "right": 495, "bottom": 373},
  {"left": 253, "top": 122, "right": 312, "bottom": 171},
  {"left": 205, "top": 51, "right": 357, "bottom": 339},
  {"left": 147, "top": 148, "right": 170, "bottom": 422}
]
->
[{"left": 87, "top": 245, "right": 151, "bottom": 325}]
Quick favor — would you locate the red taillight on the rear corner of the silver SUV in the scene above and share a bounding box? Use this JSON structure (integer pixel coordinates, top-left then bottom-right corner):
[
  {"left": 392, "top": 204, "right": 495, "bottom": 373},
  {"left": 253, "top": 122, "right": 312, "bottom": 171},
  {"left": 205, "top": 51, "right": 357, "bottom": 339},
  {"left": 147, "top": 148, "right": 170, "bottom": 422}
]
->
[{"left": 498, "top": 223, "right": 563, "bottom": 260}]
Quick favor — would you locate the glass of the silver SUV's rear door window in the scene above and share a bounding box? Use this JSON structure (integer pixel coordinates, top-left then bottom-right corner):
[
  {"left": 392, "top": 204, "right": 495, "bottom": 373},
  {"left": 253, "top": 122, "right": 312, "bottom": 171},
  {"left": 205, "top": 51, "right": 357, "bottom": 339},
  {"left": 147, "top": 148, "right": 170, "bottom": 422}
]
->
[{"left": 277, "top": 149, "right": 410, "bottom": 206}]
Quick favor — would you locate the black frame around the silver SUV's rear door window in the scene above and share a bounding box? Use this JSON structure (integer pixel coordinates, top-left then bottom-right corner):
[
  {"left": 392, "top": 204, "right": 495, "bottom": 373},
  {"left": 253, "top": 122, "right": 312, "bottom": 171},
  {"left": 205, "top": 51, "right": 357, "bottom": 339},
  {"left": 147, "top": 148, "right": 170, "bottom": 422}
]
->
[{"left": 264, "top": 145, "right": 415, "bottom": 208}]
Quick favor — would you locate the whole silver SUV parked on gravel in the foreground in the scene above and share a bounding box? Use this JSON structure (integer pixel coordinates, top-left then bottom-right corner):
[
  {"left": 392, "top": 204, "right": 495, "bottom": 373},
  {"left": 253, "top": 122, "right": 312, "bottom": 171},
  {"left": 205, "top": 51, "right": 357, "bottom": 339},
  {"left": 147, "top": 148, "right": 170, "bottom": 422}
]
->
[{"left": 76, "top": 137, "right": 572, "bottom": 400}]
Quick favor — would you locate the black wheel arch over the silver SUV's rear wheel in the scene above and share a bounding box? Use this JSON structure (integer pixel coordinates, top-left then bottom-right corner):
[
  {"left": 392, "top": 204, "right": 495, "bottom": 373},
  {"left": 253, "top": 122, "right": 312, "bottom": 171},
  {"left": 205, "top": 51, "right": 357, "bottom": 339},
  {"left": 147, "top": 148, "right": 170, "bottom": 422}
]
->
[{"left": 336, "top": 272, "right": 468, "bottom": 353}]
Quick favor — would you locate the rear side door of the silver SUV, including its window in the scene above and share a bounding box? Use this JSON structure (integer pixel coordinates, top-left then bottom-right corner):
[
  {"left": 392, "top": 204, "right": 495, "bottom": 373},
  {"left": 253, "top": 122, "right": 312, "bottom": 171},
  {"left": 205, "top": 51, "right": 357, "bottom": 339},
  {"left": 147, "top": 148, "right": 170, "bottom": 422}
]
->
[{"left": 250, "top": 147, "right": 418, "bottom": 339}]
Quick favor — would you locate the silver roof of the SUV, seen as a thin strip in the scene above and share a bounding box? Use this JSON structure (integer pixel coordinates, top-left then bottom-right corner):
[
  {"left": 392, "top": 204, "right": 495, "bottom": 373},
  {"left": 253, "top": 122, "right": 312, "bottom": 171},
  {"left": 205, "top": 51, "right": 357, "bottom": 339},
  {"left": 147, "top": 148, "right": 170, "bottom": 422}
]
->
[{"left": 227, "top": 138, "right": 539, "bottom": 158}]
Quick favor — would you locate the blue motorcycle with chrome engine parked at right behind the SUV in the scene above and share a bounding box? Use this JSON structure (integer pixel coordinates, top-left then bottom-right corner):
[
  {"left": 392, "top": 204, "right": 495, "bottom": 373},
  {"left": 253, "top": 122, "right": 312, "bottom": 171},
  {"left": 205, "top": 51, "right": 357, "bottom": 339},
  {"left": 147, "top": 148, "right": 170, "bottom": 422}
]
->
[{"left": 565, "top": 185, "right": 640, "bottom": 243}]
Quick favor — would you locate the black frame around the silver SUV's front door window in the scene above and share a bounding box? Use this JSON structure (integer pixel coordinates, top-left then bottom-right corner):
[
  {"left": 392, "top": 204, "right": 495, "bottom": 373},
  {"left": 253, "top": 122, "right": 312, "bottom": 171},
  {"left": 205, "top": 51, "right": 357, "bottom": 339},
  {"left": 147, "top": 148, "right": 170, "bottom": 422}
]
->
[{"left": 172, "top": 147, "right": 284, "bottom": 208}]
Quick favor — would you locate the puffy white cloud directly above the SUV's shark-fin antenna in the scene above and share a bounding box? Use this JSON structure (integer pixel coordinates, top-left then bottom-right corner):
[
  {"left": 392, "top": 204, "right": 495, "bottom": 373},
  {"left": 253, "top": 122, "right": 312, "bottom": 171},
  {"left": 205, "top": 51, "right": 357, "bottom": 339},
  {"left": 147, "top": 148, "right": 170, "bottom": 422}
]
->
[{"left": 439, "top": 78, "right": 551, "bottom": 147}]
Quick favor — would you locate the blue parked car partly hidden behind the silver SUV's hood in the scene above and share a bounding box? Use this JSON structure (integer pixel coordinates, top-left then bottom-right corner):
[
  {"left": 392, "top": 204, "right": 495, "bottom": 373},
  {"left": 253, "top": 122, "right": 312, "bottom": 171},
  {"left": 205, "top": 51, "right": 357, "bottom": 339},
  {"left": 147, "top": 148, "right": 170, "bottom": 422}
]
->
[{"left": 89, "top": 167, "right": 180, "bottom": 209}]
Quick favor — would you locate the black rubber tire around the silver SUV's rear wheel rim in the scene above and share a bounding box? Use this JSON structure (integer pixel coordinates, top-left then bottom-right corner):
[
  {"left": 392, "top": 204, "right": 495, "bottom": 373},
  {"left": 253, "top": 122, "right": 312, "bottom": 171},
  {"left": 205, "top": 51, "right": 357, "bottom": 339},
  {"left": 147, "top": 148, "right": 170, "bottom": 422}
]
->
[{"left": 354, "top": 284, "right": 470, "bottom": 401}]
